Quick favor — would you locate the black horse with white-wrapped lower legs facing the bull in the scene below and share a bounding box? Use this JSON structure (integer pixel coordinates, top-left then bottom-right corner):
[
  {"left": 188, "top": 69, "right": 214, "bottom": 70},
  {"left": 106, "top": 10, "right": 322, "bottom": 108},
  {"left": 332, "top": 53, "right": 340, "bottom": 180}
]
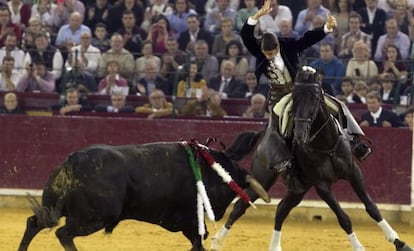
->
[{"left": 211, "top": 67, "right": 413, "bottom": 251}]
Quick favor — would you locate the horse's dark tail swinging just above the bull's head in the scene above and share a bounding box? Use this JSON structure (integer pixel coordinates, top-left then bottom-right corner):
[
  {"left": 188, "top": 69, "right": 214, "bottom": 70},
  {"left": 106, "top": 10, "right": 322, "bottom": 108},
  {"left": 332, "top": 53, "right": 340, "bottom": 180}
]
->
[{"left": 226, "top": 130, "right": 265, "bottom": 161}]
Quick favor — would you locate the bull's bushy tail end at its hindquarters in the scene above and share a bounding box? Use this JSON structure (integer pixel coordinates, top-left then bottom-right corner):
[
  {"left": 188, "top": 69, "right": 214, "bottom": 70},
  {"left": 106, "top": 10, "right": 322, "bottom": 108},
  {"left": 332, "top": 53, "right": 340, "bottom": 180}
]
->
[{"left": 27, "top": 193, "right": 63, "bottom": 228}]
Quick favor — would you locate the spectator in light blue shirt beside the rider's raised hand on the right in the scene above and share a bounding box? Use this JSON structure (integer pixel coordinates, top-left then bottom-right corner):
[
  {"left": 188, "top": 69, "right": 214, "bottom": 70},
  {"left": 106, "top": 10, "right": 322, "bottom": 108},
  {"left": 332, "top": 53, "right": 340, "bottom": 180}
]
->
[{"left": 294, "top": 0, "right": 330, "bottom": 36}]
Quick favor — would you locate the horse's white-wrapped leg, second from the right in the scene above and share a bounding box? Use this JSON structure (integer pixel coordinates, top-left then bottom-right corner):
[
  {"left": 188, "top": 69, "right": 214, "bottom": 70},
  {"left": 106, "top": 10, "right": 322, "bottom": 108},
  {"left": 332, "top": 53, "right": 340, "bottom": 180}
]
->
[{"left": 315, "top": 182, "right": 365, "bottom": 251}]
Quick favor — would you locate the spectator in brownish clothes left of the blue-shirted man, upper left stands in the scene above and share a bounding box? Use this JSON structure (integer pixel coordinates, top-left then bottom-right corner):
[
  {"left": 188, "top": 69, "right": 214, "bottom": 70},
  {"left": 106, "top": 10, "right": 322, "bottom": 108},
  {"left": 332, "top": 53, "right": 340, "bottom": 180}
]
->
[{"left": 21, "top": 16, "right": 50, "bottom": 51}]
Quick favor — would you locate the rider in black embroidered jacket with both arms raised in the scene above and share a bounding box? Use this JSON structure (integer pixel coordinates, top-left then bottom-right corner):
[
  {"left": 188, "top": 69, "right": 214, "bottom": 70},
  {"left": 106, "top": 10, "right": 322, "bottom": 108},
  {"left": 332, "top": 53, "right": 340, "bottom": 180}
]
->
[{"left": 240, "top": 0, "right": 372, "bottom": 171}]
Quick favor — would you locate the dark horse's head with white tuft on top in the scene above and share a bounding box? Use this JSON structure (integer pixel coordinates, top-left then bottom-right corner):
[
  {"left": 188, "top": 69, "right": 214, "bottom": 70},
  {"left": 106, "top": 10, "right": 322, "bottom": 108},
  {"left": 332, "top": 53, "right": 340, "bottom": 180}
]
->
[{"left": 292, "top": 66, "right": 323, "bottom": 144}]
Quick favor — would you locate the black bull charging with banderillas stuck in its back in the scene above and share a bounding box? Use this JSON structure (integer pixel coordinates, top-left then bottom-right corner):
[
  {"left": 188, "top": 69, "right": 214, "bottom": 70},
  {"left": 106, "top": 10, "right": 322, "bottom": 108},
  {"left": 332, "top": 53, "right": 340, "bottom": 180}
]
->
[{"left": 18, "top": 142, "right": 269, "bottom": 251}]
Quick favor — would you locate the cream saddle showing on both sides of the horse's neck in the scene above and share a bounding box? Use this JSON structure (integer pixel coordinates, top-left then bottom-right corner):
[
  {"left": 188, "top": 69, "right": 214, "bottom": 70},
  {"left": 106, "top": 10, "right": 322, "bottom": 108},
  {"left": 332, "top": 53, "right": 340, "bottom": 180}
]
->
[{"left": 272, "top": 93, "right": 346, "bottom": 139}]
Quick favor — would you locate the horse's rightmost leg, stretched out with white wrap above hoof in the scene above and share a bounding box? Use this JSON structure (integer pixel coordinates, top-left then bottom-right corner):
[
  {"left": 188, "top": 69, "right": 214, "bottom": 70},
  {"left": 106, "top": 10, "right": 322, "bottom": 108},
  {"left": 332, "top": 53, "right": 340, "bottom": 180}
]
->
[{"left": 349, "top": 164, "right": 413, "bottom": 251}]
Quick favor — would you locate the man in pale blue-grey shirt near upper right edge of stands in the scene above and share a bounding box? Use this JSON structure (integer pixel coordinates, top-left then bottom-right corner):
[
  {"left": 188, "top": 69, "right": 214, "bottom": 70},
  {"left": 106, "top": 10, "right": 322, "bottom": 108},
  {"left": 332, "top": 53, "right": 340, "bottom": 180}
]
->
[{"left": 374, "top": 19, "right": 411, "bottom": 62}]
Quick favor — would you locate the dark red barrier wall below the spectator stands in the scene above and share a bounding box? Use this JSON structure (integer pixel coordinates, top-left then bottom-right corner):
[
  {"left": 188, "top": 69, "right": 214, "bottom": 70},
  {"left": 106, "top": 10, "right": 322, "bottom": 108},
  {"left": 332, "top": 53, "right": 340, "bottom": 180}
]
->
[{"left": 0, "top": 115, "right": 411, "bottom": 204}]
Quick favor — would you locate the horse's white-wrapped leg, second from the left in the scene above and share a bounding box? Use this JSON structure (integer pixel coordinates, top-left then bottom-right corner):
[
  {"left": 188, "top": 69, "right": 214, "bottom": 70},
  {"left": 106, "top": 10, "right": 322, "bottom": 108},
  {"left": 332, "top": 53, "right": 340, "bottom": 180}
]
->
[{"left": 269, "top": 178, "right": 310, "bottom": 251}]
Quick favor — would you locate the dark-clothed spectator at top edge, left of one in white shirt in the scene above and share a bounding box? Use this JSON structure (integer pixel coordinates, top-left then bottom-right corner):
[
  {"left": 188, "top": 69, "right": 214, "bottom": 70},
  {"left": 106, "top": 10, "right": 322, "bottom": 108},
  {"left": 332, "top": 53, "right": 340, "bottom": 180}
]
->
[{"left": 105, "top": 0, "right": 144, "bottom": 34}]
